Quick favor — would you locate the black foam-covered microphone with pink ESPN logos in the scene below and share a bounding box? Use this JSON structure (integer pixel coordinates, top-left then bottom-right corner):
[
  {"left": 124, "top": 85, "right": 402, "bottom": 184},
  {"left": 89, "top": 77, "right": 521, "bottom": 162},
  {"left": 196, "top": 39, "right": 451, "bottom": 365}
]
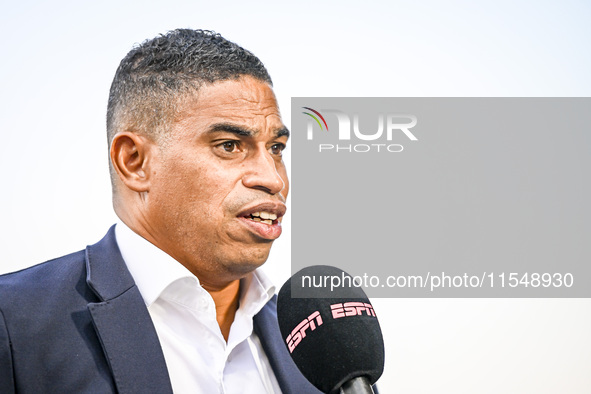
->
[{"left": 277, "top": 265, "right": 384, "bottom": 394}]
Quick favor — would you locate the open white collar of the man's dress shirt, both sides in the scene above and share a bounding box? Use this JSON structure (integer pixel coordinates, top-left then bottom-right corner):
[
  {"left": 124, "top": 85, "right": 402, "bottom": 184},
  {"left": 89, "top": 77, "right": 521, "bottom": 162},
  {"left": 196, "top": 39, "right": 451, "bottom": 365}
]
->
[{"left": 115, "top": 221, "right": 275, "bottom": 310}]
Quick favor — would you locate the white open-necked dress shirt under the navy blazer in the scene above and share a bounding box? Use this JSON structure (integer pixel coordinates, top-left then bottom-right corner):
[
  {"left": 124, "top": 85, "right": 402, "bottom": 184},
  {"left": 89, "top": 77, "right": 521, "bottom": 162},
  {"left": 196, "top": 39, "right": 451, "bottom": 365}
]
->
[{"left": 115, "top": 222, "right": 281, "bottom": 394}]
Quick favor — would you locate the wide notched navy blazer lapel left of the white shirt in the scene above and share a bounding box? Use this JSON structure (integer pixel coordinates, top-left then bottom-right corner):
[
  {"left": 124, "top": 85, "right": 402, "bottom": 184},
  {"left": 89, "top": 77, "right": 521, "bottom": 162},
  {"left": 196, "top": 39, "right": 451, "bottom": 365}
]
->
[{"left": 86, "top": 226, "right": 172, "bottom": 393}]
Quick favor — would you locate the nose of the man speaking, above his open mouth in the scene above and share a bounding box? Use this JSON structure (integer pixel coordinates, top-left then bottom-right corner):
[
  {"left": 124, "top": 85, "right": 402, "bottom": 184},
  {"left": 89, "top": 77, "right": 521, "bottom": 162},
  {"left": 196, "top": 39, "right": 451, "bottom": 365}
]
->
[{"left": 242, "top": 149, "right": 285, "bottom": 194}]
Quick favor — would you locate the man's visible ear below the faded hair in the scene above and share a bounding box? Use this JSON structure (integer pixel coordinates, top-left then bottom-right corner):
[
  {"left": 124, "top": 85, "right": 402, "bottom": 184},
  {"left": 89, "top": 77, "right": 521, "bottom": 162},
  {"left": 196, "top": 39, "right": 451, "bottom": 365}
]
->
[{"left": 110, "top": 131, "right": 155, "bottom": 192}]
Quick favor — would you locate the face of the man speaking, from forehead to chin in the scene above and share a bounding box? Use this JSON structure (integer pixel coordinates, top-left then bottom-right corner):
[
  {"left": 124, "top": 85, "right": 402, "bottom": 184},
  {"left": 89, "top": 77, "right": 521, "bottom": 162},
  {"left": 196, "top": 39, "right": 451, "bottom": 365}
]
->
[{"left": 146, "top": 77, "right": 289, "bottom": 284}]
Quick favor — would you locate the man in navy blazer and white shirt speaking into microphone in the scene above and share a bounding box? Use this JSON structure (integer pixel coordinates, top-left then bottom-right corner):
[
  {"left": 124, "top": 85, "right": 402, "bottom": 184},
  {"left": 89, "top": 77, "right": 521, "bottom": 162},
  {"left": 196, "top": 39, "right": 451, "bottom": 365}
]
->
[{"left": 0, "top": 29, "right": 318, "bottom": 393}]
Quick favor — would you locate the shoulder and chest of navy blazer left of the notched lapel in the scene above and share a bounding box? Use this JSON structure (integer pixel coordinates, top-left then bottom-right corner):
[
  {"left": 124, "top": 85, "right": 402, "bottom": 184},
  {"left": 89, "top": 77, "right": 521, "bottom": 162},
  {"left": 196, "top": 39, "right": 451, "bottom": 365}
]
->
[{"left": 0, "top": 243, "right": 122, "bottom": 393}]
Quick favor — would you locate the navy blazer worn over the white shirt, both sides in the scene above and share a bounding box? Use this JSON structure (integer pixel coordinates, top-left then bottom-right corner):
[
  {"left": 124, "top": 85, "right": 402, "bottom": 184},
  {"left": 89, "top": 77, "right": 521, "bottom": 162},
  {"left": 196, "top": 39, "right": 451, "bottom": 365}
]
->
[{"left": 0, "top": 226, "right": 320, "bottom": 394}]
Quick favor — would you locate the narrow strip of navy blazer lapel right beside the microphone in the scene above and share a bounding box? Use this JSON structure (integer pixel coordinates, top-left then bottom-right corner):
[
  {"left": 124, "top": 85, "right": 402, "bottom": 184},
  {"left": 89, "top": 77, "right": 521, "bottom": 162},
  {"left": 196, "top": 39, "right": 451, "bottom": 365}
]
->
[{"left": 254, "top": 296, "right": 321, "bottom": 394}]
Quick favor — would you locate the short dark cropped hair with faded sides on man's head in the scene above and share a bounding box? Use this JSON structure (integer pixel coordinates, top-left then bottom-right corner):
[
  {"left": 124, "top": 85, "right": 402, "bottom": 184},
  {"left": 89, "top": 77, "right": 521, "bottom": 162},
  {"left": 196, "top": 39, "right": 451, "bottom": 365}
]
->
[{"left": 107, "top": 29, "right": 273, "bottom": 145}]
